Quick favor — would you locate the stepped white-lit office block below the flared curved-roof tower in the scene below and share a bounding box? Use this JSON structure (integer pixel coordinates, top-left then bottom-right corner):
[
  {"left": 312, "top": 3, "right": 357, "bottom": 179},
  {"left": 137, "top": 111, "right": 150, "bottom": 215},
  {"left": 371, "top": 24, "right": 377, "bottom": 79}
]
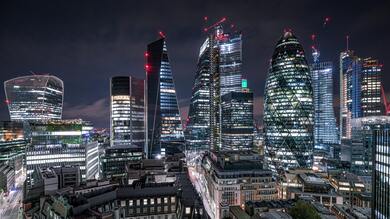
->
[{"left": 26, "top": 120, "right": 99, "bottom": 179}]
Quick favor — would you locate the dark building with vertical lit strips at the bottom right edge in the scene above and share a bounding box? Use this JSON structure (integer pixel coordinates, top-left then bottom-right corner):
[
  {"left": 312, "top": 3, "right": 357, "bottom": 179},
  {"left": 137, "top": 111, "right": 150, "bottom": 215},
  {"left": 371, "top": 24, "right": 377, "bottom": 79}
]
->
[{"left": 371, "top": 120, "right": 390, "bottom": 219}]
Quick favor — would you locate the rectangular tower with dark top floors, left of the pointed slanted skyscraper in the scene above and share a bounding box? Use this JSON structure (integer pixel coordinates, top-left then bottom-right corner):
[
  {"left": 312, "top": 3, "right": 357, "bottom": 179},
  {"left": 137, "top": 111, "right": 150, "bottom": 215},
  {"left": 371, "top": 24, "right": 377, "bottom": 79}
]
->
[{"left": 110, "top": 76, "right": 145, "bottom": 148}]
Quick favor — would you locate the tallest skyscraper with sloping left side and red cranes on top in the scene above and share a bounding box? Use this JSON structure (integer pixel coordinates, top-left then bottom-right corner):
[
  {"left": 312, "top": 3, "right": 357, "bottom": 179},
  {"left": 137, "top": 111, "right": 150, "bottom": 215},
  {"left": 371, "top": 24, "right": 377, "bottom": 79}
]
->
[{"left": 187, "top": 25, "right": 242, "bottom": 149}]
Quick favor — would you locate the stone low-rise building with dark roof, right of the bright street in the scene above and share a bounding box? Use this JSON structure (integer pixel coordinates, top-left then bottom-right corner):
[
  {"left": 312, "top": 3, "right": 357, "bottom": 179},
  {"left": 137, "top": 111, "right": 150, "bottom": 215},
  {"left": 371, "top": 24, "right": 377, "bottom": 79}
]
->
[{"left": 202, "top": 151, "right": 278, "bottom": 218}]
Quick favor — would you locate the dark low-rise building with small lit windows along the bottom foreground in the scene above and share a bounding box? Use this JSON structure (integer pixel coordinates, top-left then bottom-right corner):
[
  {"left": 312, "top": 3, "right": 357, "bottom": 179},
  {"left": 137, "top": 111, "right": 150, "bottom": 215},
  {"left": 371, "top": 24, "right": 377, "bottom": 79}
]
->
[{"left": 34, "top": 174, "right": 208, "bottom": 219}]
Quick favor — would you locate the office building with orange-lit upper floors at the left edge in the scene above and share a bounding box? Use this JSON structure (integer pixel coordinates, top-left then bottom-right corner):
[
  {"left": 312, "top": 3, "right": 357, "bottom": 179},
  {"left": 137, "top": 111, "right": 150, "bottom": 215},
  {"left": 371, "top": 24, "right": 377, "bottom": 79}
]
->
[{"left": 0, "top": 121, "right": 28, "bottom": 175}]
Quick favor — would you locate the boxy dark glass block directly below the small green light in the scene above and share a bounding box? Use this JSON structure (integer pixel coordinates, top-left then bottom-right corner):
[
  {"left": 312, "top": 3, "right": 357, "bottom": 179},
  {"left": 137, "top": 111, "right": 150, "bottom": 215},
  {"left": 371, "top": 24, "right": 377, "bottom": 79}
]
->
[{"left": 221, "top": 91, "right": 254, "bottom": 150}]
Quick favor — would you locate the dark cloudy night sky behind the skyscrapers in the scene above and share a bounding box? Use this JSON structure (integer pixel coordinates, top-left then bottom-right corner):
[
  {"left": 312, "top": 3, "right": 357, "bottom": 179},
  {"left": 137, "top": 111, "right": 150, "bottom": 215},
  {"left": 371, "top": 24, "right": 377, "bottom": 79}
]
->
[{"left": 0, "top": 0, "right": 390, "bottom": 127}]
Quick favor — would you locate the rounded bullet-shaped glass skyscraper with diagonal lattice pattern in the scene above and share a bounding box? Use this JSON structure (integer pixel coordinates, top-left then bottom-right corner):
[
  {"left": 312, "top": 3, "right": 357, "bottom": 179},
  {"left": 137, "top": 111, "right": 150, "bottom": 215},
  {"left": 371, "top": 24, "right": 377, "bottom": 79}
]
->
[{"left": 264, "top": 31, "right": 314, "bottom": 171}]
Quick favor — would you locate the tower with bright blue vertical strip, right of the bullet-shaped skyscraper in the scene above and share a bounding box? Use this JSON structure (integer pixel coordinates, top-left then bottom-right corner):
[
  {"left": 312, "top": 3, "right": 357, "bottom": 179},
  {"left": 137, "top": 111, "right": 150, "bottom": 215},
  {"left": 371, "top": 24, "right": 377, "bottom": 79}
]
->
[{"left": 340, "top": 50, "right": 384, "bottom": 139}]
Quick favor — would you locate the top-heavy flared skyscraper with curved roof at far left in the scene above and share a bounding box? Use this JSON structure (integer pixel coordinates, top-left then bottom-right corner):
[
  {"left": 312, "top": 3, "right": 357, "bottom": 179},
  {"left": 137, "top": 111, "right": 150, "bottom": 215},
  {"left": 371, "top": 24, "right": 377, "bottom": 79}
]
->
[{"left": 4, "top": 75, "right": 64, "bottom": 121}]
